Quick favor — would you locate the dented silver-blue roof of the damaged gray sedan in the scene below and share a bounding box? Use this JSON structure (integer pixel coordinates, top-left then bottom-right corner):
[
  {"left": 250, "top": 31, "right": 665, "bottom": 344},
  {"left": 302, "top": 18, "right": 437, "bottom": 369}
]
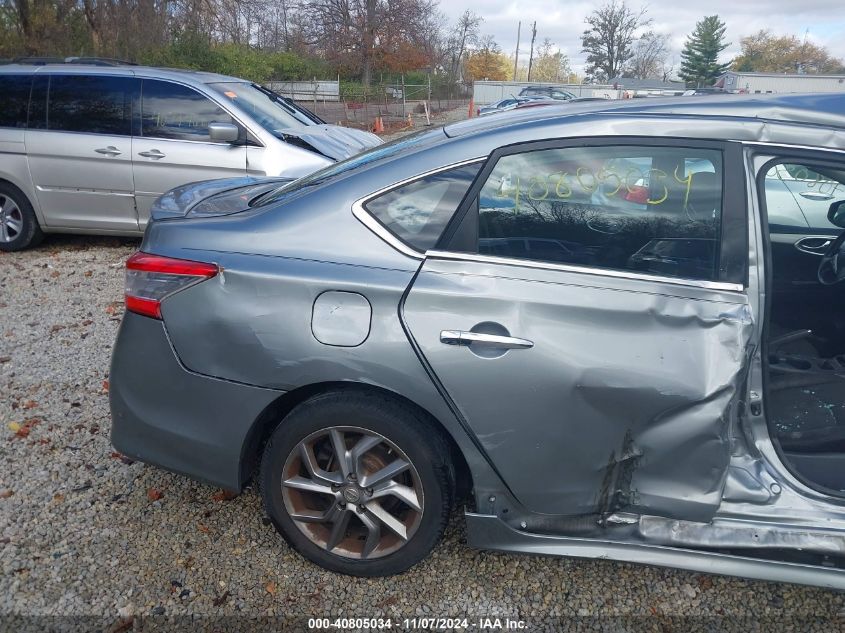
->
[{"left": 444, "top": 93, "right": 845, "bottom": 137}]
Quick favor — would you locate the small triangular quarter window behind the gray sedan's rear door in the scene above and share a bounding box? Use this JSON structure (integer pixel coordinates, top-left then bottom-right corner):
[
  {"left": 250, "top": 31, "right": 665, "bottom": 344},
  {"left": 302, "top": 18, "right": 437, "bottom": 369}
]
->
[{"left": 364, "top": 162, "right": 481, "bottom": 251}]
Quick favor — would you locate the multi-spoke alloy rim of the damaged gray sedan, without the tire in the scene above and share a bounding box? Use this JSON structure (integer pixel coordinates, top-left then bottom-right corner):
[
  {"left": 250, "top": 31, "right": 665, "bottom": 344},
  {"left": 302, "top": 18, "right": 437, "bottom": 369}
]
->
[{"left": 281, "top": 427, "right": 424, "bottom": 560}]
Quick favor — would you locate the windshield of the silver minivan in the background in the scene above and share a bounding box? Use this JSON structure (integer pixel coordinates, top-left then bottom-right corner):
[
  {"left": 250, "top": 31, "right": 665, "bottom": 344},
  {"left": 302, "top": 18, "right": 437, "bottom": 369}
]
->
[{"left": 209, "top": 81, "right": 317, "bottom": 136}]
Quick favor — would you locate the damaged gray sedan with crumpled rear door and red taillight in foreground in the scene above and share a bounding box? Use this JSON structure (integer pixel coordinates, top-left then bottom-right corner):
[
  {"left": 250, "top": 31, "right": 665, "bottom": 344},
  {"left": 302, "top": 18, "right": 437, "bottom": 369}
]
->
[{"left": 110, "top": 95, "right": 845, "bottom": 588}]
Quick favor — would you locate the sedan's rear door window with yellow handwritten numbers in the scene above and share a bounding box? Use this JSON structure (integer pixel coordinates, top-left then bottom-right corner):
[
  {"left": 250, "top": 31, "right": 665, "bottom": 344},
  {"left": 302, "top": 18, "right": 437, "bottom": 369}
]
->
[{"left": 478, "top": 145, "right": 723, "bottom": 280}]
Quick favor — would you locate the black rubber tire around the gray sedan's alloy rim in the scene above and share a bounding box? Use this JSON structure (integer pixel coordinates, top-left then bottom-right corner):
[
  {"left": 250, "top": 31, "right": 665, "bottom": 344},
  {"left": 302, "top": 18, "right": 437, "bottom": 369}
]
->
[{"left": 259, "top": 390, "right": 455, "bottom": 576}]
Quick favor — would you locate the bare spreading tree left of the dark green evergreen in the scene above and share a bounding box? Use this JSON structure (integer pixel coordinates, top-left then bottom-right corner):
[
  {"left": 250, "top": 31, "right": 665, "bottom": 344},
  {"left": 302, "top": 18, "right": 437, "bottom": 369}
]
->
[{"left": 581, "top": 0, "right": 651, "bottom": 81}]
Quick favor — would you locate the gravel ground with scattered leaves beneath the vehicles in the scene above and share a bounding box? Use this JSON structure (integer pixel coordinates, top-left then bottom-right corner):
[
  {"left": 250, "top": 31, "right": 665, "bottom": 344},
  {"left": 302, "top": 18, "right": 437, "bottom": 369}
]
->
[{"left": 0, "top": 236, "right": 843, "bottom": 630}]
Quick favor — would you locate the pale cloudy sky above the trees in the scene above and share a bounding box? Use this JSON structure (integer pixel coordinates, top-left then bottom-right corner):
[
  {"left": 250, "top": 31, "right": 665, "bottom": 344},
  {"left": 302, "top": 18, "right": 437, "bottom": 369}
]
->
[{"left": 440, "top": 0, "right": 845, "bottom": 72}]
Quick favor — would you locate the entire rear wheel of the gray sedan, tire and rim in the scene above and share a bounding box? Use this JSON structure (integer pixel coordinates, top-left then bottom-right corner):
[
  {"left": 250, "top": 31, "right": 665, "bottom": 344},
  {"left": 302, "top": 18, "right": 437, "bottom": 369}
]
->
[{"left": 260, "top": 391, "right": 454, "bottom": 576}]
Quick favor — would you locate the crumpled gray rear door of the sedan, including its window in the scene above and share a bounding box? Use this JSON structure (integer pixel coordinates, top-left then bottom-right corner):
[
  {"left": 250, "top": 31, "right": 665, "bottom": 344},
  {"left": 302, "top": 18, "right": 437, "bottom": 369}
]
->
[{"left": 402, "top": 138, "right": 756, "bottom": 521}]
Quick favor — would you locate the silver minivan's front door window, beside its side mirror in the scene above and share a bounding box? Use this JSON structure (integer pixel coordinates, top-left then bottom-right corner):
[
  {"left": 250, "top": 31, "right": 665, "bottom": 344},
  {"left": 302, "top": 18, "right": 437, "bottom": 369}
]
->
[{"left": 141, "top": 79, "right": 235, "bottom": 142}]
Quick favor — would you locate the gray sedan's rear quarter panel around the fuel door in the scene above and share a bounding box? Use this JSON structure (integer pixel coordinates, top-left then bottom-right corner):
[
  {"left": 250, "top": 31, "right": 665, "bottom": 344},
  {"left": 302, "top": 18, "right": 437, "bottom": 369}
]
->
[{"left": 142, "top": 173, "right": 502, "bottom": 491}]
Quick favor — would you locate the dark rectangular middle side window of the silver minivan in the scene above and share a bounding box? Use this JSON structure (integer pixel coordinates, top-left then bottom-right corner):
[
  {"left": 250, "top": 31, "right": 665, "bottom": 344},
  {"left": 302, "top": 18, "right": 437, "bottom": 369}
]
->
[{"left": 47, "top": 75, "right": 137, "bottom": 136}]
